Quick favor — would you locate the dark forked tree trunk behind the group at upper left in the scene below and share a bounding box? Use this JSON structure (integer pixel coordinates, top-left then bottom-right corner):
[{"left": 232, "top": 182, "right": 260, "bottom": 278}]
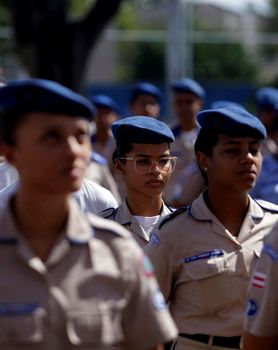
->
[{"left": 4, "top": 0, "right": 122, "bottom": 90}]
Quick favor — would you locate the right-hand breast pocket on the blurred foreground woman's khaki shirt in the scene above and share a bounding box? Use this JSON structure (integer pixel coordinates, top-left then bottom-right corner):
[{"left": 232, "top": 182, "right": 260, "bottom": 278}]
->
[{"left": 67, "top": 305, "right": 123, "bottom": 346}]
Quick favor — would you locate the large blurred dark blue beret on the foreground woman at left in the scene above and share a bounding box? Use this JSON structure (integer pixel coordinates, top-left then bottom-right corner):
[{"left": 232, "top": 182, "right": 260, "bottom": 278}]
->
[{"left": 0, "top": 79, "right": 94, "bottom": 120}]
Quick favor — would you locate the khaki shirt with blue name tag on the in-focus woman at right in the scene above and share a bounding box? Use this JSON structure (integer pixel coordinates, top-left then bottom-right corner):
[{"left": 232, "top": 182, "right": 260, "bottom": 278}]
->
[{"left": 145, "top": 194, "right": 278, "bottom": 337}]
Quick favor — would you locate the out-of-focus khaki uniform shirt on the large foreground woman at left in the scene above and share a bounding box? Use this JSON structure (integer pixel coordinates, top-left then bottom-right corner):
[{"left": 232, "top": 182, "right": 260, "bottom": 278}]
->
[{"left": 0, "top": 196, "right": 176, "bottom": 350}]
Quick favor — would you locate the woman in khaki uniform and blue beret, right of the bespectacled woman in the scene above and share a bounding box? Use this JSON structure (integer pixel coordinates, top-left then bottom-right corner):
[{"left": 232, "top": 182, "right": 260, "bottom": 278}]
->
[{"left": 145, "top": 107, "right": 278, "bottom": 350}]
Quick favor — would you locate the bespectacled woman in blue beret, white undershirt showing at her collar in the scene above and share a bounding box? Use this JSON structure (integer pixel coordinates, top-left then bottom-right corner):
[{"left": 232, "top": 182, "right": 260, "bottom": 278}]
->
[{"left": 101, "top": 116, "right": 176, "bottom": 247}]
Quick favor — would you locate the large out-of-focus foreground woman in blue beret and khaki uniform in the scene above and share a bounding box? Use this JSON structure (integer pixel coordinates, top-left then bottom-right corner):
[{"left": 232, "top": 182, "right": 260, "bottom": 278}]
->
[{"left": 0, "top": 79, "right": 175, "bottom": 350}]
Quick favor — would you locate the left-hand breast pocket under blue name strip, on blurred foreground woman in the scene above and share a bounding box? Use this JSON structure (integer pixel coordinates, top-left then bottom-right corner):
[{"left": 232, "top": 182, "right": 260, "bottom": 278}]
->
[{"left": 0, "top": 310, "right": 44, "bottom": 348}]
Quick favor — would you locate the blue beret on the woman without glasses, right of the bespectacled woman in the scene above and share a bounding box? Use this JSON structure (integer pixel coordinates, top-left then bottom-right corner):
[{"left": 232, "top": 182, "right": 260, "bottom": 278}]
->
[{"left": 197, "top": 107, "right": 266, "bottom": 139}]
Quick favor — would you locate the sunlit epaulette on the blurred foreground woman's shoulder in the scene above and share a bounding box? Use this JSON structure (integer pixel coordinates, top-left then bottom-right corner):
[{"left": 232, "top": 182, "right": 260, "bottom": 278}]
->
[{"left": 88, "top": 214, "right": 131, "bottom": 238}]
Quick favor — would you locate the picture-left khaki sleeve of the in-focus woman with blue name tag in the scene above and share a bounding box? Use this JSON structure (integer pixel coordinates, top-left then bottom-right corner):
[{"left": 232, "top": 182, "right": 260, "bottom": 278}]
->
[{"left": 144, "top": 230, "right": 173, "bottom": 302}]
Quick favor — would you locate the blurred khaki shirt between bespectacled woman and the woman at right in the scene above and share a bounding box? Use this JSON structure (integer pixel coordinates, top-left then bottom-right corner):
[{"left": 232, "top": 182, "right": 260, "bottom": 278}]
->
[{"left": 163, "top": 127, "right": 199, "bottom": 205}]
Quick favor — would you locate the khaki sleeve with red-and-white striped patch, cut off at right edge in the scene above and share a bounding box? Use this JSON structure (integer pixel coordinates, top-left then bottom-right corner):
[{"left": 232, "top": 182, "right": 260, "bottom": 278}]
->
[{"left": 245, "top": 225, "right": 278, "bottom": 337}]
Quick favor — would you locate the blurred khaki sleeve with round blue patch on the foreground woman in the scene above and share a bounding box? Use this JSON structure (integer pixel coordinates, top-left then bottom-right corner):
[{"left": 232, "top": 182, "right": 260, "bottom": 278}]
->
[{"left": 123, "top": 242, "right": 177, "bottom": 350}]
